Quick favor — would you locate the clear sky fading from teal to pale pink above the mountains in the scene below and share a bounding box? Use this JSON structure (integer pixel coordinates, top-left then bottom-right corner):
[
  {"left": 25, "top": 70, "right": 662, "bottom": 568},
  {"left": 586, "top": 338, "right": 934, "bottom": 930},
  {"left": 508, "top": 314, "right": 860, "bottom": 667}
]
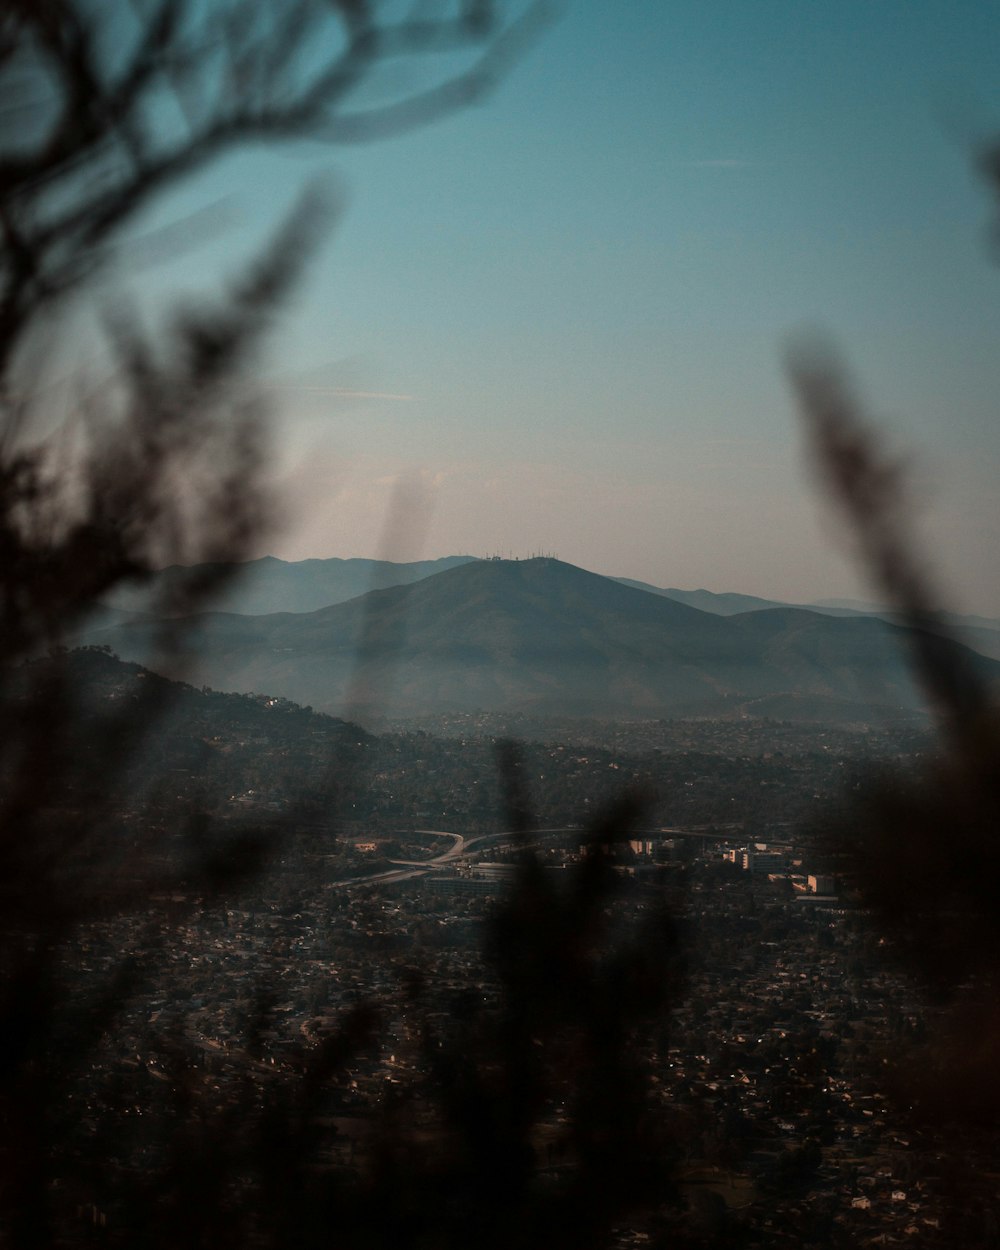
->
[{"left": 107, "top": 0, "right": 1000, "bottom": 616}]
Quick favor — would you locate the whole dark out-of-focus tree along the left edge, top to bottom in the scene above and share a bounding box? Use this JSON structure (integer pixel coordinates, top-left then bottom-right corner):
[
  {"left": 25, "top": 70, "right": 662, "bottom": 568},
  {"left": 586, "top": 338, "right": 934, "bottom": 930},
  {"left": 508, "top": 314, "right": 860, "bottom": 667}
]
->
[{"left": 0, "top": 0, "right": 562, "bottom": 1248}]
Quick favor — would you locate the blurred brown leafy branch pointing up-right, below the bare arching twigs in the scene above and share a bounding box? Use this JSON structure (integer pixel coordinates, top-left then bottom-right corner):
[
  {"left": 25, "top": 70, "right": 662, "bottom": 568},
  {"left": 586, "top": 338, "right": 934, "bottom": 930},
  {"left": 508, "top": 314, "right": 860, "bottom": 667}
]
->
[{"left": 0, "top": 187, "right": 329, "bottom": 663}]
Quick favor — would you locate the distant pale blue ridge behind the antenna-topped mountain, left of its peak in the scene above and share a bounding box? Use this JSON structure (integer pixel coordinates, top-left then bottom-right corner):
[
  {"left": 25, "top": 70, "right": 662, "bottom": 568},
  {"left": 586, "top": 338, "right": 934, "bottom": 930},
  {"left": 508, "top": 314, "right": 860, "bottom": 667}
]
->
[{"left": 105, "top": 555, "right": 474, "bottom": 616}]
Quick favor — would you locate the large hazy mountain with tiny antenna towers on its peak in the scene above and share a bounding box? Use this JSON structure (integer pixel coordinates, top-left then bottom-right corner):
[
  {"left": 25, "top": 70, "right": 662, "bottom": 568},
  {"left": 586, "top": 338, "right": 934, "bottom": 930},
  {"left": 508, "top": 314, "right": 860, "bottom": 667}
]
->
[{"left": 83, "top": 559, "right": 1000, "bottom": 720}]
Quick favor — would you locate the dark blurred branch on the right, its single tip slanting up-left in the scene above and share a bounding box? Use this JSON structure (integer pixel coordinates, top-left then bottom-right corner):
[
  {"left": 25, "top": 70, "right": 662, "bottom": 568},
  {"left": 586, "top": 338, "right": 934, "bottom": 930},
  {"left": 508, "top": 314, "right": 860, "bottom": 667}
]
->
[{"left": 789, "top": 346, "right": 1000, "bottom": 1128}]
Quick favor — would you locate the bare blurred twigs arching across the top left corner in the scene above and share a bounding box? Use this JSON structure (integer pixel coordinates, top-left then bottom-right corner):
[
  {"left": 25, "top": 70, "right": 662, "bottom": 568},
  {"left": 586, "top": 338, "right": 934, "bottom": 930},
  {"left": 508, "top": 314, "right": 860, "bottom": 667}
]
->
[{"left": 0, "top": 0, "right": 554, "bottom": 373}]
